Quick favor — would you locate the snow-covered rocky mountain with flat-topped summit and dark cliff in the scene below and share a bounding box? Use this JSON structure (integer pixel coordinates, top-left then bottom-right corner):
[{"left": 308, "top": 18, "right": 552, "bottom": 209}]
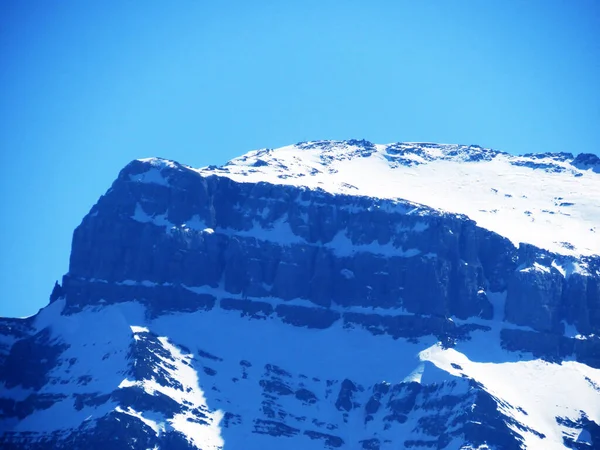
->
[{"left": 0, "top": 140, "right": 600, "bottom": 450}]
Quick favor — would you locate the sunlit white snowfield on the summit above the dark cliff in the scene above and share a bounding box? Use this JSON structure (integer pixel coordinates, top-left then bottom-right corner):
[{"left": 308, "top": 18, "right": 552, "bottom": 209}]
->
[{"left": 196, "top": 141, "right": 600, "bottom": 255}]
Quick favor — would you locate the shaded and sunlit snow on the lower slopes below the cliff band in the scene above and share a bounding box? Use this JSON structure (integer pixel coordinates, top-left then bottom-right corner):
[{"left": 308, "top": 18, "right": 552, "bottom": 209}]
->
[{"left": 3, "top": 292, "right": 600, "bottom": 449}]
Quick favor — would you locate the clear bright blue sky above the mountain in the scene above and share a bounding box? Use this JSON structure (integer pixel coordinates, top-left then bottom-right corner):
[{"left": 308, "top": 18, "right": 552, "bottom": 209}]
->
[{"left": 0, "top": 0, "right": 600, "bottom": 316}]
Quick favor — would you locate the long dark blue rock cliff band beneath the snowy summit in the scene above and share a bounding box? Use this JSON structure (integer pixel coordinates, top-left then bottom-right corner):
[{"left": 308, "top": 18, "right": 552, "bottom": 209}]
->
[{"left": 63, "top": 161, "right": 600, "bottom": 342}]
